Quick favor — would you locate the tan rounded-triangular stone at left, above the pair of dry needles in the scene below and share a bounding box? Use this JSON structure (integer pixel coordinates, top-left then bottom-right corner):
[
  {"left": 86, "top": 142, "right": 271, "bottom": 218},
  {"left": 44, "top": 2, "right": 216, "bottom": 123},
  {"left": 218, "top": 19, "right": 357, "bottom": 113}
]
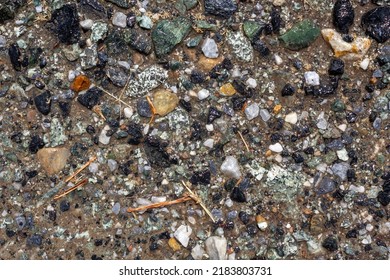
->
[{"left": 37, "top": 147, "right": 70, "bottom": 175}]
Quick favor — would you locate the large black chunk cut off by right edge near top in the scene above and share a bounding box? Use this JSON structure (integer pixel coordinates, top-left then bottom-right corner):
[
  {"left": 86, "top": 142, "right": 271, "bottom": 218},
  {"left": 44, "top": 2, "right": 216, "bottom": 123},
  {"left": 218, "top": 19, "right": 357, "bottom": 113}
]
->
[{"left": 361, "top": 6, "right": 390, "bottom": 43}]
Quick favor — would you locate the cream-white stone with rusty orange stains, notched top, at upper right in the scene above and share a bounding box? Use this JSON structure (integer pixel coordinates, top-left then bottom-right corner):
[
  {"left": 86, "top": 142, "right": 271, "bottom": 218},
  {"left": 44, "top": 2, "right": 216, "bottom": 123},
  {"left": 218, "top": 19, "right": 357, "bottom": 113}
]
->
[{"left": 321, "top": 29, "right": 371, "bottom": 60}]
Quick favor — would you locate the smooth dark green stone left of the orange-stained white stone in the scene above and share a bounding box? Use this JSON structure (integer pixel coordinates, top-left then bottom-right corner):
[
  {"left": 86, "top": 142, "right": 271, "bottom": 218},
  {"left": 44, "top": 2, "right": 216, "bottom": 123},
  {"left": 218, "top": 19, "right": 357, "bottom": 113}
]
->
[{"left": 279, "top": 19, "right": 320, "bottom": 51}]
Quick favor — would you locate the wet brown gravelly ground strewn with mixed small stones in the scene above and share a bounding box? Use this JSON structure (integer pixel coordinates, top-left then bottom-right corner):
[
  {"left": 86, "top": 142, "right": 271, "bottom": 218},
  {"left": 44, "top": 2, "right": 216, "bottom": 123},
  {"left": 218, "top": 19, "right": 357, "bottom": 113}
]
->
[{"left": 0, "top": 0, "right": 390, "bottom": 259}]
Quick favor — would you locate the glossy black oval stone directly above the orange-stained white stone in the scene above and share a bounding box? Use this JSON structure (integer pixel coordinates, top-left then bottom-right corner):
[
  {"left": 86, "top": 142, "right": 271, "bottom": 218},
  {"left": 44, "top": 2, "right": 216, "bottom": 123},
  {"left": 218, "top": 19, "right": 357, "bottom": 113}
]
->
[{"left": 333, "top": 0, "right": 355, "bottom": 33}]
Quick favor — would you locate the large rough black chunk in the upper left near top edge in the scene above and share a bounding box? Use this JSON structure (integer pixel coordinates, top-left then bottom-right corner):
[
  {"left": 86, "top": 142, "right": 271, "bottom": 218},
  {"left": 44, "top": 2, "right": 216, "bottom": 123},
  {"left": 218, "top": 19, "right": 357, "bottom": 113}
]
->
[{"left": 51, "top": 4, "right": 80, "bottom": 45}]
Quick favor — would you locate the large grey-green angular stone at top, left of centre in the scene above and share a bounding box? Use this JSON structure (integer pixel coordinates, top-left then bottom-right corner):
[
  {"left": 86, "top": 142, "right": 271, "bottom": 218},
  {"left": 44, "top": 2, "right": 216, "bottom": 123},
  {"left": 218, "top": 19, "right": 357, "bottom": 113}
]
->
[{"left": 152, "top": 17, "right": 191, "bottom": 57}]
